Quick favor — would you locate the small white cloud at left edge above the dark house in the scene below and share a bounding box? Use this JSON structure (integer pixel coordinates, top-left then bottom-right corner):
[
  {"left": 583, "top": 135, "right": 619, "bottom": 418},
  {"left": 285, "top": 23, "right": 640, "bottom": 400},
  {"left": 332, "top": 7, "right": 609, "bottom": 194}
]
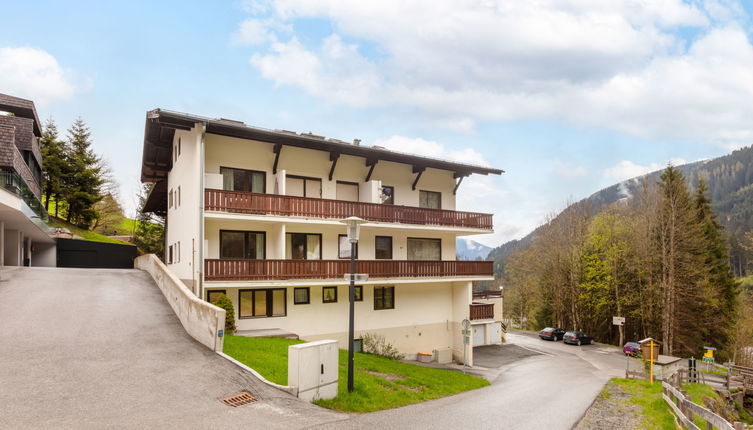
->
[{"left": 0, "top": 47, "right": 76, "bottom": 104}]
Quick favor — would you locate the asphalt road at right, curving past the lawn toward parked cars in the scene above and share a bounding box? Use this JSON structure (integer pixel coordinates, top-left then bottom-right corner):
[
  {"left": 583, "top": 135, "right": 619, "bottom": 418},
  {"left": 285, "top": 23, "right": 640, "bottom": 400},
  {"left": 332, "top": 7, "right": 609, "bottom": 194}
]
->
[{"left": 320, "top": 332, "right": 625, "bottom": 430}]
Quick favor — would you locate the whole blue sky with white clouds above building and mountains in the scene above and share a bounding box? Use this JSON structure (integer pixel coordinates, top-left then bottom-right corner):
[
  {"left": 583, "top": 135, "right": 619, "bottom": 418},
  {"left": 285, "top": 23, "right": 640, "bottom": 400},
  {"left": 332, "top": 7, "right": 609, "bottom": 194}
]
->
[{"left": 0, "top": 0, "right": 753, "bottom": 245}]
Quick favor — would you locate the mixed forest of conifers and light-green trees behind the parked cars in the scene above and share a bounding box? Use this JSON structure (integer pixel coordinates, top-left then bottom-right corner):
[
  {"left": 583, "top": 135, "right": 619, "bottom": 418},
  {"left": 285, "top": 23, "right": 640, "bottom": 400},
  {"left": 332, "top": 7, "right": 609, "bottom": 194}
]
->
[{"left": 502, "top": 166, "right": 753, "bottom": 360}]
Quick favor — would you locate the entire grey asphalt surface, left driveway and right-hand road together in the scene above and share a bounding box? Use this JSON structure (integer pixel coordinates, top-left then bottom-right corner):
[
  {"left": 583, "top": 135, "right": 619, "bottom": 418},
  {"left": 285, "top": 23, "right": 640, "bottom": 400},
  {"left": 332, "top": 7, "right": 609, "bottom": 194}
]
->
[{"left": 0, "top": 268, "right": 624, "bottom": 430}]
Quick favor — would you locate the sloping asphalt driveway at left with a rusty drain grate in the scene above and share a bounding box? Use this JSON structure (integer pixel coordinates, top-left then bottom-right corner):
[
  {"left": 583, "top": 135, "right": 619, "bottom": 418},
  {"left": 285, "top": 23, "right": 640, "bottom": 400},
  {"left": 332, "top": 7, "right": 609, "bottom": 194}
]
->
[{"left": 0, "top": 268, "right": 346, "bottom": 429}]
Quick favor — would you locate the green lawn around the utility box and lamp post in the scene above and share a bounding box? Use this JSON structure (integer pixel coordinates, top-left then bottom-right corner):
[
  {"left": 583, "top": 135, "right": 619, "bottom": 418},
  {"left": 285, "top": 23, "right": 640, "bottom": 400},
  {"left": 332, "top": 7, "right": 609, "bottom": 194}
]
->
[{"left": 224, "top": 336, "right": 489, "bottom": 412}]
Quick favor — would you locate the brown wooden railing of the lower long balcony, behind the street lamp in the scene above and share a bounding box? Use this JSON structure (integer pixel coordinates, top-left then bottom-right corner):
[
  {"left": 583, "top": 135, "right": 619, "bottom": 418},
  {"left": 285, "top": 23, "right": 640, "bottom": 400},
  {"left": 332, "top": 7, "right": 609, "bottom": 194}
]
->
[{"left": 204, "top": 260, "right": 492, "bottom": 281}]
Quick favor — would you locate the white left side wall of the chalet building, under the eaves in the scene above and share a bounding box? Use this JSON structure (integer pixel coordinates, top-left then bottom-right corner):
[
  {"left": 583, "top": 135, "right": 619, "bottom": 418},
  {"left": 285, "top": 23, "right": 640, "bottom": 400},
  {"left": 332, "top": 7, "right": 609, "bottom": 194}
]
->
[{"left": 165, "top": 126, "right": 202, "bottom": 291}]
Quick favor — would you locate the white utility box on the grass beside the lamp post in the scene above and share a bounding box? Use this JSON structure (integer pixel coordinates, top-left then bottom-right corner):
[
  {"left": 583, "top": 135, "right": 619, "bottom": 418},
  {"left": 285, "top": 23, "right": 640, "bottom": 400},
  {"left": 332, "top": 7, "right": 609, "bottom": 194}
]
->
[{"left": 288, "top": 340, "right": 338, "bottom": 402}]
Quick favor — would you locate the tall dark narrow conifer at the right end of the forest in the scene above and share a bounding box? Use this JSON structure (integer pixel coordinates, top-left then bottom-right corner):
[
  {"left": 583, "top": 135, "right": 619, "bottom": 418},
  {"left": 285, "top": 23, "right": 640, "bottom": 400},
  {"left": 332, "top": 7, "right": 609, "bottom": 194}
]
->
[{"left": 694, "top": 179, "right": 739, "bottom": 358}]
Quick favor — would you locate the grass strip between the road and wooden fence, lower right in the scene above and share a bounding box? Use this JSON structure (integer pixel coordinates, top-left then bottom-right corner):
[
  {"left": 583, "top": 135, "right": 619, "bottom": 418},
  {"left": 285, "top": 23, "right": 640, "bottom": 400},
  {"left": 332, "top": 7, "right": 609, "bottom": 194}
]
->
[{"left": 610, "top": 378, "right": 676, "bottom": 430}]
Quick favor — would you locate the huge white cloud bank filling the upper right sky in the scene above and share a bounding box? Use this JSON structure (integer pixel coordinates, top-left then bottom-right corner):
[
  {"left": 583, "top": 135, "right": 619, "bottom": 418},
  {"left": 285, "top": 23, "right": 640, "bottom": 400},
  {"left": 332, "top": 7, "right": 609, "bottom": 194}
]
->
[{"left": 239, "top": 0, "right": 753, "bottom": 146}]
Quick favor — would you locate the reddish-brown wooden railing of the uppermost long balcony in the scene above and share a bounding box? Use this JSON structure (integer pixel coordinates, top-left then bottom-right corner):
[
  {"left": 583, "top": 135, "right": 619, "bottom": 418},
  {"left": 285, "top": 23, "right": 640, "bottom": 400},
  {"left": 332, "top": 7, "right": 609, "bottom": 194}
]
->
[{"left": 204, "top": 189, "right": 493, "bottom": 230}]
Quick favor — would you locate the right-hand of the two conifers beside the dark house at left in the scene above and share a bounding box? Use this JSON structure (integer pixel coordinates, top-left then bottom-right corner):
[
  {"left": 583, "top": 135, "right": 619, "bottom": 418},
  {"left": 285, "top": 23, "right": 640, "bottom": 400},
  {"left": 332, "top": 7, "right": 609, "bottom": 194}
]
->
[{"left": 65, "top": 118, "right": 103, "bottom": 228}]
